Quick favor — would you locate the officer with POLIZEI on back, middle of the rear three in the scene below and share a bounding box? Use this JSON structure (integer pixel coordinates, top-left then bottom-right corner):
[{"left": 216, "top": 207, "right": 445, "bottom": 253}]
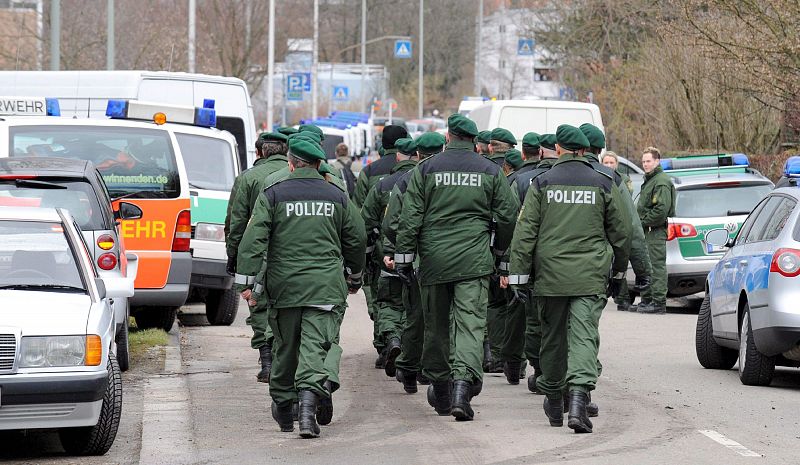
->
[{"left": 394, "top": 114, "right": 516, "bottom": 420}]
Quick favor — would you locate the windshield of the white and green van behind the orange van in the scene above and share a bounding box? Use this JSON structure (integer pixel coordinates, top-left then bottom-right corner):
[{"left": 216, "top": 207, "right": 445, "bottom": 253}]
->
[{"left": 175, "top": 133, "right": 236, "bottom": 191}]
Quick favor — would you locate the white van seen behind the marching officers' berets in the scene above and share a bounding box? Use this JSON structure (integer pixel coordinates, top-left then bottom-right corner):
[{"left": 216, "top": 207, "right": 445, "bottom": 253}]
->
[{"left": 469, "top": 100, "right": 605, "bottom": 141}]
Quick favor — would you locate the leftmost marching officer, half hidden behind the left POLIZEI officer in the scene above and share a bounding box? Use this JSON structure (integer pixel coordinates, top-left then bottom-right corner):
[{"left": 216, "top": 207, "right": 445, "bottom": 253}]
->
[{"left": 225, "top": 132, "right": 288, "bottom": 383}]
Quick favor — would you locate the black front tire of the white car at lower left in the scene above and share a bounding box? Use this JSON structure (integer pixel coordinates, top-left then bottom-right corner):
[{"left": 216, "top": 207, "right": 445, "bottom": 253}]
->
[{"left": 58, "top": 356, "right": 122, "bottom": 455}]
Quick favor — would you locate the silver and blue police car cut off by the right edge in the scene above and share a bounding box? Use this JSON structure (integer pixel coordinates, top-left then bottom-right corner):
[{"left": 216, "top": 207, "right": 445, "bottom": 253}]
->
[{"left": 696, "top": 187, "right": 800, "bottom": 385}]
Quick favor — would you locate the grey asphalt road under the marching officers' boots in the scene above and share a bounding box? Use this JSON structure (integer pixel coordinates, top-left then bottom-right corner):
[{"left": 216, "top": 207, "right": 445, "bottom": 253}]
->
[{"left": 0, "top": 294, "right": 800, "bottom": 465}]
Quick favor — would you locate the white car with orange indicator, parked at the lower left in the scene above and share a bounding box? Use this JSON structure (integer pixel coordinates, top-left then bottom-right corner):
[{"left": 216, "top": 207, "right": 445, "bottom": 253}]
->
[{"left": 0, "top": 207, "right": 138, "bottom": 455}]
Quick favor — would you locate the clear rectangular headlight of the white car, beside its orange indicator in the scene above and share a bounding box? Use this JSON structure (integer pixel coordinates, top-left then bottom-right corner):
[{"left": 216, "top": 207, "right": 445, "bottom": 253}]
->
[{"left": 19, "top": 336, "right": 86, "bottom": 368}]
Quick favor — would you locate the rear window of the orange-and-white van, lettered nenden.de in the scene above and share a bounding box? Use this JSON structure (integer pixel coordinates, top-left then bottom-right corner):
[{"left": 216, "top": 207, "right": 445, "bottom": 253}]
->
[{"left": 9, "top": 125, "right": 180, "bottom": 198}]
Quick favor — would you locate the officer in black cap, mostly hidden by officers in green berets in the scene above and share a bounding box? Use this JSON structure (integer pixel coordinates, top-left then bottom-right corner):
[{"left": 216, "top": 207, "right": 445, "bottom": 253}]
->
[{"left": 353, "top": 124, "right": 408, "bottom": 368}]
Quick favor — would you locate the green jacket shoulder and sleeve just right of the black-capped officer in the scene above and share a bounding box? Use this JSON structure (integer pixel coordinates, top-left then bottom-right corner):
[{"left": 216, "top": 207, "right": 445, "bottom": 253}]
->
[{"left": 361, "top": 160, "right": 417, "bottom": 268}]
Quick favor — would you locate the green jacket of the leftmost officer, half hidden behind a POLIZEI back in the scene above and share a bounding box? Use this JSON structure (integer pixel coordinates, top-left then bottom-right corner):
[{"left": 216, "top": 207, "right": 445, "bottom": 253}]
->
[{"left": 225, "top": 155, "right": 287, "bottom": 258}]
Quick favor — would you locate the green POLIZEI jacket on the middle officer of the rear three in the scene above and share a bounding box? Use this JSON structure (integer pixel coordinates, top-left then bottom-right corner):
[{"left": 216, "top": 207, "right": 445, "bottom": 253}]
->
[{"left": 394, "top": 140, "right": 516, "bottom": 285}]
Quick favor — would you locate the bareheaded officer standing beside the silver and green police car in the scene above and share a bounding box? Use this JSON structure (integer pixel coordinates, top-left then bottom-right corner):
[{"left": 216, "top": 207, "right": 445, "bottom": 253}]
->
[{"left": 636, "top": 147, "right": 675, "bottom": 314}]
